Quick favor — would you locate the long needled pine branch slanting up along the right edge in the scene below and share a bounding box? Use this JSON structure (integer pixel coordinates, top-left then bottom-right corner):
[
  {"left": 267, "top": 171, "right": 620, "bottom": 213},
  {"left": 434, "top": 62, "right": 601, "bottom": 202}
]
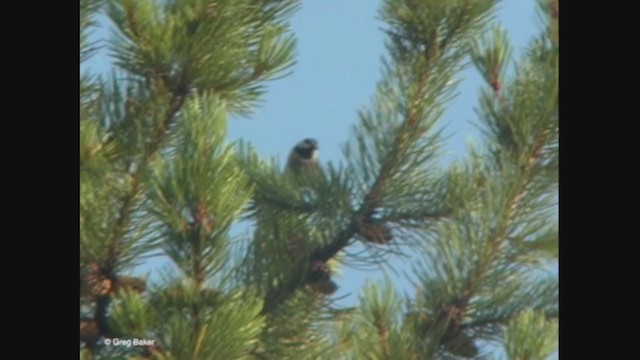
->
[{"left": 408, "top": 6, "right": 556, "bottom": 354}]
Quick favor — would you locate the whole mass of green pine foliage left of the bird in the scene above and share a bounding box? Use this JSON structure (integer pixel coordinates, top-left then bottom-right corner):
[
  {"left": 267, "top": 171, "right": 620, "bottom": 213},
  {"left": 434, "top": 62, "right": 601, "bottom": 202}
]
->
[{"left": 80, "top": 0, "right": 298, "bottom": 359}]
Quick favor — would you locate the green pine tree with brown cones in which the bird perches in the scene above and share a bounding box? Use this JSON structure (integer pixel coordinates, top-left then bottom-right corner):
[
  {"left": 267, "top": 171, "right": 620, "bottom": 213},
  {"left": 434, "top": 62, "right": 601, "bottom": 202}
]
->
[{"left": 80, "top": 0, "right": 559, "bottom": 359}]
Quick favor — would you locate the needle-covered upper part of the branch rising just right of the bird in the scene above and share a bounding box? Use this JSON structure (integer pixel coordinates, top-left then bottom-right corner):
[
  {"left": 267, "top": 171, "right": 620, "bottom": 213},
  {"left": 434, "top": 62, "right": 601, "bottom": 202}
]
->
[{"left": 345, "top": 1, "right": 495, "bottom": 238}]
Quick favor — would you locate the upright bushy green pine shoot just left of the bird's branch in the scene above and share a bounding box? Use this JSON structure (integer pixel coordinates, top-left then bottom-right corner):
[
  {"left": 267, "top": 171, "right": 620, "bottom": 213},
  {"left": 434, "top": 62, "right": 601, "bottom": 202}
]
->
[{"left": 150, "top": 96, "right": 251, "bottom": 281}]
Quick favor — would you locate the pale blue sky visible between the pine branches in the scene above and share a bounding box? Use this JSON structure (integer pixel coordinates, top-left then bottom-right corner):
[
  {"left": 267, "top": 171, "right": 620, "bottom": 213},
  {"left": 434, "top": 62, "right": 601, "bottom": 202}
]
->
[{"left": 83, "top": 0, "right": 556, "bottom": 358}]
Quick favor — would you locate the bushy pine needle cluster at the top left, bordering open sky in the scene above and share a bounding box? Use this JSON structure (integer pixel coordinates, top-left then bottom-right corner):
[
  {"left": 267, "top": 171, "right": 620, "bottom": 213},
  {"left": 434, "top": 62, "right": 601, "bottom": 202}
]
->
[{"left": 109, "top": 0, "right": 298, "bottom": 114}]
